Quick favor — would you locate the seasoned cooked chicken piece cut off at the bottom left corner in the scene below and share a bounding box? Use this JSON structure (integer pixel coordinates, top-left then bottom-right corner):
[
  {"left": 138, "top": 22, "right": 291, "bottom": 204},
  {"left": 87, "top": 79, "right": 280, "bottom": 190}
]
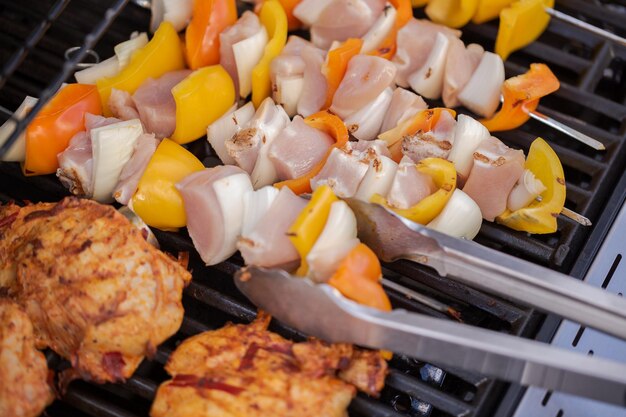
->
[{"left": 0, "top": 299, "right": 54, "bottom": 417}]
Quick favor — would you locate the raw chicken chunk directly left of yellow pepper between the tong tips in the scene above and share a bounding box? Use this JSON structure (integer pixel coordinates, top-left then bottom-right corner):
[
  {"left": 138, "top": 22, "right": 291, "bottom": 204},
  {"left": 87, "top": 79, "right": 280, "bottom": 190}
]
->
[{"left": 237, "top": 187, "right": 307, "bottom": 269}]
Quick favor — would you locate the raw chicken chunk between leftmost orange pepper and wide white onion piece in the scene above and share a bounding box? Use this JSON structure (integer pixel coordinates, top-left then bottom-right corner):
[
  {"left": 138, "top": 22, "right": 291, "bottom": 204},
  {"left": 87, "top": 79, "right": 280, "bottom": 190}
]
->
[{"left": 56, "top": 113, "right": 121, "bottom": 197}]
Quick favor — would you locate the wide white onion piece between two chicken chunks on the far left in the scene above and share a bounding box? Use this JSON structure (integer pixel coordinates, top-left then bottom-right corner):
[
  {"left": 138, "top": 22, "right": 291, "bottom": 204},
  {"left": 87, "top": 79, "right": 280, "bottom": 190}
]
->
[{"left": 91, "top": 119, "right": 143, "bottom": 203}]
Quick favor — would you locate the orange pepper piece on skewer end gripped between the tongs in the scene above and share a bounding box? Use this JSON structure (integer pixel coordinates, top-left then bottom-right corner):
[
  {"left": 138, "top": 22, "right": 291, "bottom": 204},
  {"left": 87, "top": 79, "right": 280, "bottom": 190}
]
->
[{"left": 328, "top": 243, "right": 391, "bottom": 311}]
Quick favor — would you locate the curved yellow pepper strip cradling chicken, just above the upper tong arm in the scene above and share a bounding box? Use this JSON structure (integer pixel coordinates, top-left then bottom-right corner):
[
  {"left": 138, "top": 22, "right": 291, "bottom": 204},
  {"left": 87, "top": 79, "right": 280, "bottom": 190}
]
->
[{"left": 371, "top": 158, "right": 456, "bottom": 224}]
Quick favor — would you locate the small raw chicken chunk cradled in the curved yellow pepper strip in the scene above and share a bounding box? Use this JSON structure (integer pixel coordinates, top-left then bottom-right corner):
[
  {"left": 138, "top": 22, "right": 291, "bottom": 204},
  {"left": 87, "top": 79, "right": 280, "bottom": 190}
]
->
[{"left": 387, "top": 156, "right": 437, "bottom": 209}]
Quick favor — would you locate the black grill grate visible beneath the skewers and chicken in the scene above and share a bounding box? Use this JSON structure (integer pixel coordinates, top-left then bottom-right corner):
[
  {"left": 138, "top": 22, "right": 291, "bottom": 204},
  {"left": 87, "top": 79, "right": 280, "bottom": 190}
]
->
[{"left": 0, "top": 0, "right": 626, "bottom": 417}]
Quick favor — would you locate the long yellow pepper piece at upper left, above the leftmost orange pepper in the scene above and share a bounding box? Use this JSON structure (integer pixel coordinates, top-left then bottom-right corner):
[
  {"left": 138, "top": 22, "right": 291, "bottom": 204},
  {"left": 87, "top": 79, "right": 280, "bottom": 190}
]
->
[{"left": 96, "top": 22, "right": 185, "bottom": 117}]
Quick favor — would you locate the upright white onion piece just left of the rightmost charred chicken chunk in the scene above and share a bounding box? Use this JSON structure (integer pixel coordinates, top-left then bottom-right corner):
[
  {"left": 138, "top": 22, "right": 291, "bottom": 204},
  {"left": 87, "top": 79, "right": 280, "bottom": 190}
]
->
[{"left": 448, "top": 114, "right": 491, "bottom": 179}]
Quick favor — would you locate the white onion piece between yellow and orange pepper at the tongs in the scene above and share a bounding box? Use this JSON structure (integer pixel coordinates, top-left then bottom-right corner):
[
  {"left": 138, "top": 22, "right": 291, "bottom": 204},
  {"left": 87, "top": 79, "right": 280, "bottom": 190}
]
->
[{"left": 306, "top": 201, "right": 359, "bottom": 282}]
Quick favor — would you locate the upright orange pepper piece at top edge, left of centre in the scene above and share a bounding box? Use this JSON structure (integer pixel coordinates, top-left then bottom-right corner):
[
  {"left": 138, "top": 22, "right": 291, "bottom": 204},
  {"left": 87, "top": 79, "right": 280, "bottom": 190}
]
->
[{"left": 185, "top": 0, "right": 237, "bottom": 70}]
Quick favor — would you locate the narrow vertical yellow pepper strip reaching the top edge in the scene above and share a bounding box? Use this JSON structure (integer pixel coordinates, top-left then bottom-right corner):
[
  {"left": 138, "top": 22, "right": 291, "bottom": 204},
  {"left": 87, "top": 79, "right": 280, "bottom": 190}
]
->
[{"left": 252, "top": 0, "right": 287, "bottom": 108}]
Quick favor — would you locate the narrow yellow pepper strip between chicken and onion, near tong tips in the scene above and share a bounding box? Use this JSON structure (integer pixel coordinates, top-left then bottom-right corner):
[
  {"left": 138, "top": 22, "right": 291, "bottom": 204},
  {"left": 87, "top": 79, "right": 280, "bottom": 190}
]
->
[{"left": 287, "top": 185, "right": 339, "bottom": 276}]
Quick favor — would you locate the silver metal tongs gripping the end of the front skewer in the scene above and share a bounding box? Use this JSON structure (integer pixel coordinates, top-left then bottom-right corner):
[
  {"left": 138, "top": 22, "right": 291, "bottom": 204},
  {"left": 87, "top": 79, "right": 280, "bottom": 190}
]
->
[{"left": 235, "top": 200, "right": 626, "bottom": 406}]
